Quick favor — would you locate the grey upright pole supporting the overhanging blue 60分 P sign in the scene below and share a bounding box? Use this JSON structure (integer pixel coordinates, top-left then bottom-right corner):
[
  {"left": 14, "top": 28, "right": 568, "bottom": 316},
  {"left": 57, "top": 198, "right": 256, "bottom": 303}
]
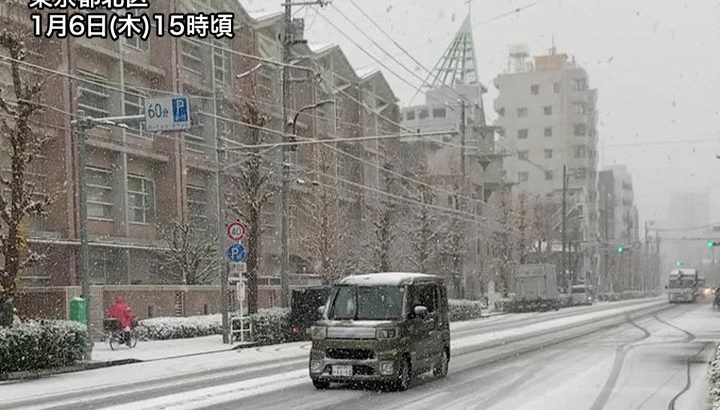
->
[{"left": 75, "top": 110, "right": 93, "bottom": 360}]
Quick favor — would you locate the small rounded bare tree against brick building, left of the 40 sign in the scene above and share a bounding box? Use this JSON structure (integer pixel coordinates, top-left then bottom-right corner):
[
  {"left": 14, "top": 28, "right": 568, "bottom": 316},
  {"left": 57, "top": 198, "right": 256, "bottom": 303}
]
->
[{"left": 158, "top": 221, "right": 219, "bottom": 285}]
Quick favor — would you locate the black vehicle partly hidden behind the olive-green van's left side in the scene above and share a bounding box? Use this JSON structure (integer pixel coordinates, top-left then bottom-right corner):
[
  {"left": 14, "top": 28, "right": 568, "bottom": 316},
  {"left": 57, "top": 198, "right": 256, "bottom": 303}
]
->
[{"left": 290, "top": 286, "right": 331, "bottom": 342}]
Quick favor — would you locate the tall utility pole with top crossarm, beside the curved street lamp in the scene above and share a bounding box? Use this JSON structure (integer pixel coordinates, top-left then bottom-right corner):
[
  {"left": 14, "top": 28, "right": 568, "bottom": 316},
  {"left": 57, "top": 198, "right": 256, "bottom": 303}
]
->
[{"left": 280, "top": 0, "right": 330, "bottom": 307}]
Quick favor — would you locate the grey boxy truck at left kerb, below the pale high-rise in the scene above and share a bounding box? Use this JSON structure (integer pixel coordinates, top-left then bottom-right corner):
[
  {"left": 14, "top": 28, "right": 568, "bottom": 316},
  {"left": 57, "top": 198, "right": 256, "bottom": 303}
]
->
[{"left": 508, "top": 263, "right": 563, "bottom": 312}]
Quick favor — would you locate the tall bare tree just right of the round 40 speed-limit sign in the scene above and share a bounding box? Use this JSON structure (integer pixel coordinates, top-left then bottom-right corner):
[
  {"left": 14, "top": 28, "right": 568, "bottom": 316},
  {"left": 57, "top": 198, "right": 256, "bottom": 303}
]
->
[{"left": 228, "top": 102, "right": 273, "bottom": 314}]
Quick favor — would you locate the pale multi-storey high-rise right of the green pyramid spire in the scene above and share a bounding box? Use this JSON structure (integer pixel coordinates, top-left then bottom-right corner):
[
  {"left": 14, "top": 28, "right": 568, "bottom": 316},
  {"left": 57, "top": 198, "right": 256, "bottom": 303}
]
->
[{"left": 494, "top": 46, "right": 598, "bottom": 282}]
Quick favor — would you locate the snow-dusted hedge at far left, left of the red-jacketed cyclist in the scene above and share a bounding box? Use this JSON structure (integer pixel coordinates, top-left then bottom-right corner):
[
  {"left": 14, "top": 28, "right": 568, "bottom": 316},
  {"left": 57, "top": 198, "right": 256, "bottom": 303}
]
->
[{"left": 0, "top": 320, "right": 89, "bottom": 374}]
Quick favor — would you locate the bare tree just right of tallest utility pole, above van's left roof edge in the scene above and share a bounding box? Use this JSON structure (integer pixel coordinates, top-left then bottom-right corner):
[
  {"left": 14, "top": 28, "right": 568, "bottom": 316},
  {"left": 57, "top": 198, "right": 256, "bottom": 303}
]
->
[{"left": 301, "top": 146, "right": 353, "bottom": 284}]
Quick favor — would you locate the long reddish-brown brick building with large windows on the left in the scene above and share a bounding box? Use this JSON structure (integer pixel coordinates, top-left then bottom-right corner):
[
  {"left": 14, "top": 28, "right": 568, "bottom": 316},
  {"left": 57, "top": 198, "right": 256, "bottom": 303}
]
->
[{"left": 0, "top": 0, "right": 399, "bottom": 292}]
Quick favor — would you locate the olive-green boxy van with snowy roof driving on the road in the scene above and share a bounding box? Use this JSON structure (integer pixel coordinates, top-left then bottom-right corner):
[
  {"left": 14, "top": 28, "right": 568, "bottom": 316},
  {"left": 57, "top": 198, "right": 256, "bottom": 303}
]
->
[{"left": 310, "top": 273, "right": 450, "bottom": 390}]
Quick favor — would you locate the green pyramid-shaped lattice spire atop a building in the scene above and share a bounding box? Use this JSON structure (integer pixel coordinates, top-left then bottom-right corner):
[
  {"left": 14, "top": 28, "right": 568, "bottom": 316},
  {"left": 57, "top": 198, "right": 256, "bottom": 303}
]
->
[{"left": 430, "top": 14, "right": 479, "bottom": 87}]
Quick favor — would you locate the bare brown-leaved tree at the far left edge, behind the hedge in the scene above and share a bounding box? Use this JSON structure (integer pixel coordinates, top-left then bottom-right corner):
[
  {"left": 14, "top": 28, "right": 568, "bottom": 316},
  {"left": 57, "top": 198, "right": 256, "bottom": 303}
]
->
[{"left": 0, "top": 30, "right": 50, "bottom": 327}]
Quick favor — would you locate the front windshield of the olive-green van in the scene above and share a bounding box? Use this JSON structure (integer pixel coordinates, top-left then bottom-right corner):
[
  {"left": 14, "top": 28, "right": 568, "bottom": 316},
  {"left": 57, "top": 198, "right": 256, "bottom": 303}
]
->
[{"left": 328, "top": 286, "right": 404, "bottom": 320}]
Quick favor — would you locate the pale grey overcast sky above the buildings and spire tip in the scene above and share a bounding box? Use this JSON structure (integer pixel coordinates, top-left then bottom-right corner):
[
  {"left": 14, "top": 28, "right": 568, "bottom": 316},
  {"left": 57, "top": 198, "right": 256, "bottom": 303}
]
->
[{"left": 245, "top": 0, "right": 720, "bottom": 229}]
